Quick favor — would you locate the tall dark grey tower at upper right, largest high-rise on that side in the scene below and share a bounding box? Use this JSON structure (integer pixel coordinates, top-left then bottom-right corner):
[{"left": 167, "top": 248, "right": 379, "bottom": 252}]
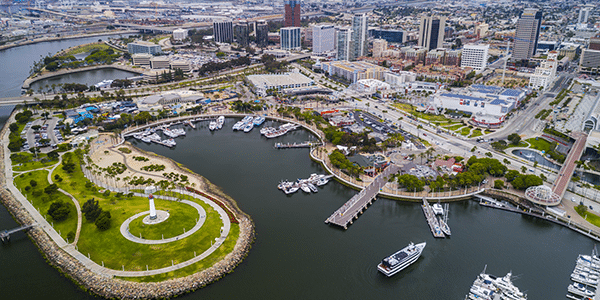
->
[{"left": 512, "top": 8, "right": 542, "bottom": 60}]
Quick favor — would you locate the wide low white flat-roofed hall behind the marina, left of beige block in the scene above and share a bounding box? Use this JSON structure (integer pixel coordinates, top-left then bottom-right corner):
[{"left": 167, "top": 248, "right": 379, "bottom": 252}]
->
[{"left": 246, "top": 70, "right": 315, "bottom": 97}]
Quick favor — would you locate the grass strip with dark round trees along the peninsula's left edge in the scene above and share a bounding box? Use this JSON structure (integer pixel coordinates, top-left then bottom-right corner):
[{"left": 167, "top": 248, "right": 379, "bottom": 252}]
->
[{"left": 14, "top": 170, "right": 77, "bottom": 240}]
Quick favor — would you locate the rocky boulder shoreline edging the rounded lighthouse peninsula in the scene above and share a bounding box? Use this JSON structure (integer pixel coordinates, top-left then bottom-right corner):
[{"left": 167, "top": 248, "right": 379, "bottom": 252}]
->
[{"left": 0, "top": 110, "right": 255, "bottom": 299}]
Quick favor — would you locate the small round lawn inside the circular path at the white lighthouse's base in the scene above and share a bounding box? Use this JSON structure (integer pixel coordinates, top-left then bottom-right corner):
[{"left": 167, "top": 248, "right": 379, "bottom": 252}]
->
[{"left": 129, "top": 199, "right": 199, "bottom": 240}]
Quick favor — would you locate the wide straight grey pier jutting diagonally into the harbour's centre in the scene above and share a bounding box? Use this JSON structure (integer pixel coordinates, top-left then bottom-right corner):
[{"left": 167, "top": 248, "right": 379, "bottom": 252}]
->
[{"left": 325, "top": 164, "right": 400, "bottom": 229}]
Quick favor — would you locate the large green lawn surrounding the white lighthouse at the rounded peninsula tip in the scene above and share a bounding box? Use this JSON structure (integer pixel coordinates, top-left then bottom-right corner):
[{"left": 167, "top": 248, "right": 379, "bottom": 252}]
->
[{"left": 54, "top": 152, "right": 239, "bottom": 281}]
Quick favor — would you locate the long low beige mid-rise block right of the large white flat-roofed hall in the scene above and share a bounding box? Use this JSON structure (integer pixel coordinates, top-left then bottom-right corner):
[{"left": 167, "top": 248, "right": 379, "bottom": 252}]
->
[{"left": 321, "top": 61, "right": 387, "bottom": 83}]
